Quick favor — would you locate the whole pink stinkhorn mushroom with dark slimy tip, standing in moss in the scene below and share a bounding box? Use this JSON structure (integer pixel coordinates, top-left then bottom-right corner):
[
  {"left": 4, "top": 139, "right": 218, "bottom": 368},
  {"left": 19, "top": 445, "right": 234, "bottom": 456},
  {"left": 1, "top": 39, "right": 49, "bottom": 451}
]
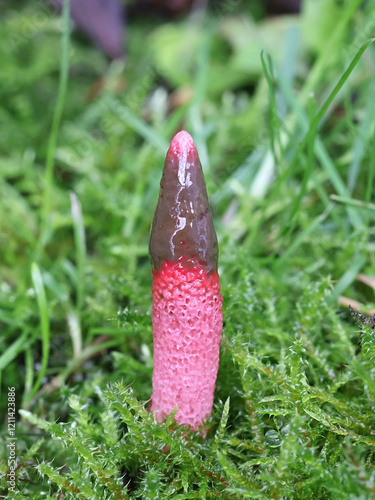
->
[{"left": 150, "top": 131, "right": 223, "bottom": 429}]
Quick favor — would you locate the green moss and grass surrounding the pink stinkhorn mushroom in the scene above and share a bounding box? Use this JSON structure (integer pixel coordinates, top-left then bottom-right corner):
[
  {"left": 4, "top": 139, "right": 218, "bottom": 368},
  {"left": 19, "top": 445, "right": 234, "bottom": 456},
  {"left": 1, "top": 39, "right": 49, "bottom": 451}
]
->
[{"left": 0, "top": 1, "right": 375, "bottom": 500}]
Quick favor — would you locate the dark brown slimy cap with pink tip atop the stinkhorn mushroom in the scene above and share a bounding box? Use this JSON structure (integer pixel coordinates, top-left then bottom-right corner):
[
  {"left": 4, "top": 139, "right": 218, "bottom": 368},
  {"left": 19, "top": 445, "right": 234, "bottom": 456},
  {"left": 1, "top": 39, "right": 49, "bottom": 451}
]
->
[{"left": 150, "top": 131, "right": 218, "bottom": 272}]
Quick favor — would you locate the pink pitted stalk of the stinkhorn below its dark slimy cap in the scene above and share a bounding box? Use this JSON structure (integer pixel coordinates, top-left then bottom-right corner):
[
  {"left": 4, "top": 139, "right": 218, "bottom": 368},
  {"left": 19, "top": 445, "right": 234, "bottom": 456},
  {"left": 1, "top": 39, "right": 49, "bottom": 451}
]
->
[{"left": 151, "top": 260, "right": 223, "bottom": 429}]
